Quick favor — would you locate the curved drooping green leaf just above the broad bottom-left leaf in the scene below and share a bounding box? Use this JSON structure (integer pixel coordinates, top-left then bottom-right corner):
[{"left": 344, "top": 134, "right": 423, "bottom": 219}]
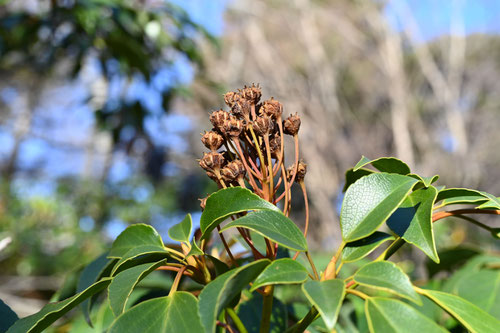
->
[{"left": 108, "top": 260, "right": 165, "bottom": 316}]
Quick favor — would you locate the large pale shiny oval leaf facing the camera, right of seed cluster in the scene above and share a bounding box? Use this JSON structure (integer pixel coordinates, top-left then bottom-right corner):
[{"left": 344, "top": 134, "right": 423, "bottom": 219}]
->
[{"left": 340, "top": 173, "right": 417, "bottom": 242}]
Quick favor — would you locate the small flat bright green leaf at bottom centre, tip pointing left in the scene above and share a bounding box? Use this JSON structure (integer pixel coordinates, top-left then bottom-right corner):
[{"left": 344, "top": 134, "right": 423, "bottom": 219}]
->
[{"left": 250, "top": 258, "right": 308, "bottom": 291}]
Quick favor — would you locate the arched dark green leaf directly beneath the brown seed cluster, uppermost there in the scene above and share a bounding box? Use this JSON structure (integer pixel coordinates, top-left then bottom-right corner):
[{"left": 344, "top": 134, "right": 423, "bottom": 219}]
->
[{"left": 200, "top": 187, "right": 280, "bottom": 239}]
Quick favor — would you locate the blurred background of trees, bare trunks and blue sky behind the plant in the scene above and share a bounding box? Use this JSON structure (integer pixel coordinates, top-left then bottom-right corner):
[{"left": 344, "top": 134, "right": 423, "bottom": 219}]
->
[{"left": 0, "top": 0, "right": 500, "bottom": 322}]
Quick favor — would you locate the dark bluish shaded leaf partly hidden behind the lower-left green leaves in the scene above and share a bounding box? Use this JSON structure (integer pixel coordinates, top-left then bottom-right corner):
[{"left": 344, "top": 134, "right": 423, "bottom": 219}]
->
[{"left": 76, "top": 253, "right": 114, "bottom": 327}]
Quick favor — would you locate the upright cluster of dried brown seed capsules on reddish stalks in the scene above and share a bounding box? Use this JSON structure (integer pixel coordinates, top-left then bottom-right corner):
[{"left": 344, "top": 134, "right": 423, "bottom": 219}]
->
[{"left": 199, "top": 84, "right": 306, "bottom": 211}]
